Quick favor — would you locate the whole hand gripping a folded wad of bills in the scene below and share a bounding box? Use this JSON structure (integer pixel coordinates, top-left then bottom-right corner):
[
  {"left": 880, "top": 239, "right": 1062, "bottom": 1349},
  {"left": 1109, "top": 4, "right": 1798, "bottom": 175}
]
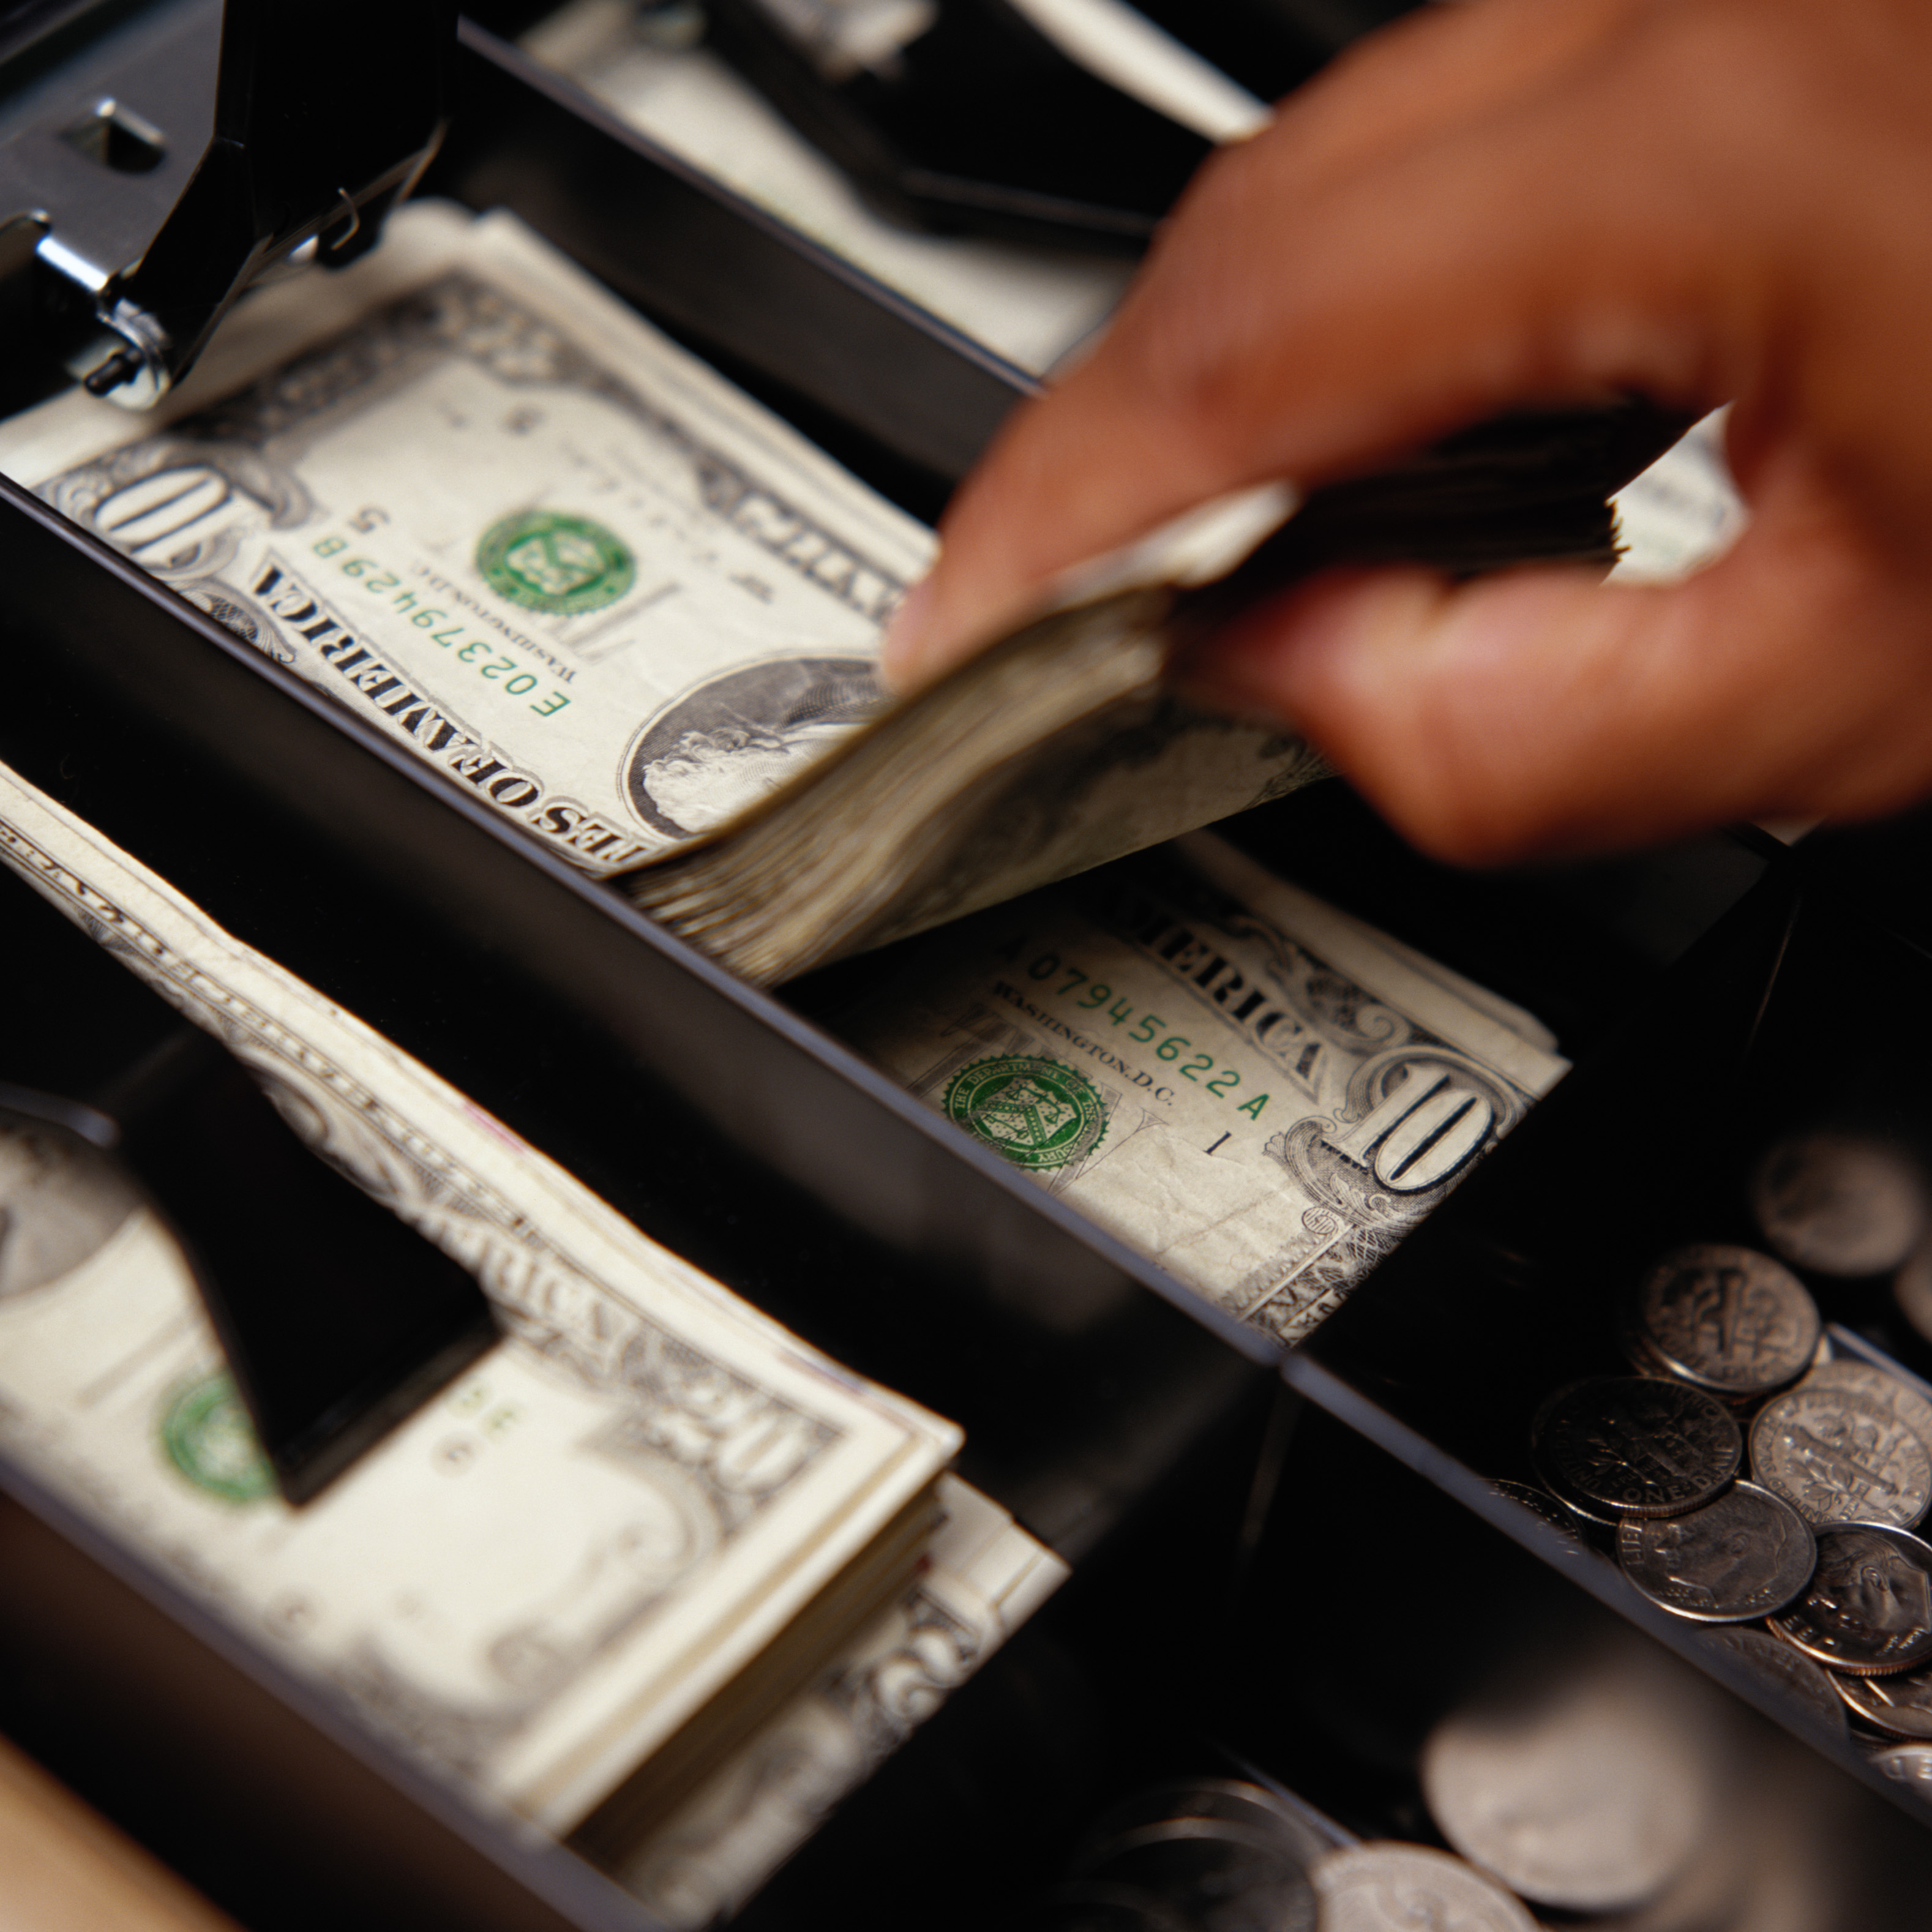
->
[{"left": 887, "top": 0, "right": 1932, "bottom": 862}]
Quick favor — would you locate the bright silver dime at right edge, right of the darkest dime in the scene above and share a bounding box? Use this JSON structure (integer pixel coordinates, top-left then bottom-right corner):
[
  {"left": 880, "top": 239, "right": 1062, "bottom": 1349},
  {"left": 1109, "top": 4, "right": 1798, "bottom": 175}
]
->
[{"left": 1750, "top": 1382, "right": 1932, "bottom": 1528}]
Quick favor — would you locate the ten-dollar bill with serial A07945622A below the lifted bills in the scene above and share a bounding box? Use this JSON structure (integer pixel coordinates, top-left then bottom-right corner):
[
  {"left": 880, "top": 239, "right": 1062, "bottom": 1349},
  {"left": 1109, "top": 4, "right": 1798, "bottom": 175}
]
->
[{"left": 833, "top": 833, "right": 1569, "bottom": 1342}]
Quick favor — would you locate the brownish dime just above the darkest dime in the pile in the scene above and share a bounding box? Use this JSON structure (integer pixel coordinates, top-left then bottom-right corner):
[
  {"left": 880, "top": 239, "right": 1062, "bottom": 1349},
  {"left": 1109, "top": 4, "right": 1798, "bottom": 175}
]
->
[{"left": 1631, "top": 1242, "right": 1818, "bottom": 1399}]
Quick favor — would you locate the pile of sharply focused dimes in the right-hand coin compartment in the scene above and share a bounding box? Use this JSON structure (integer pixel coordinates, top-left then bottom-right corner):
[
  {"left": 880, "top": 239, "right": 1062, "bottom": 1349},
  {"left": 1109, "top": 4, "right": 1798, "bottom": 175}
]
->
[{"left": 1499, "top": 1229, "right": 1932, "bottom": 1775}]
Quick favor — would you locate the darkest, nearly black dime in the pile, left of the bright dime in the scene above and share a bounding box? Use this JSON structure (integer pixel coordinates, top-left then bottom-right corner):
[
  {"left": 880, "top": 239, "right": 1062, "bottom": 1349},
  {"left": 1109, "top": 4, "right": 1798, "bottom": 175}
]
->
[{"left": 1530, "top": 1376, "right": 1745, "bottom": 1516}]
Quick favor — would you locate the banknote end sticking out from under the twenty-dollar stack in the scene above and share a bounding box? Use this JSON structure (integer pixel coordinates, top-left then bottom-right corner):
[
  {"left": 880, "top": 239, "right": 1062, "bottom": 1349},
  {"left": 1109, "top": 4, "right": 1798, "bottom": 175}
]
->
[{"left": 607, "top": 1476, "right": 1066, "bottom": 1932}]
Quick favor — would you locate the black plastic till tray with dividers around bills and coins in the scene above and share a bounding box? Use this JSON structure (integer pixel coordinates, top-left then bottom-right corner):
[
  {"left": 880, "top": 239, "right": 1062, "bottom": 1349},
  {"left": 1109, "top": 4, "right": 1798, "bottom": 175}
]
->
[{"left": 0, "top": 0, "right": 1932, "bottom": 1932}]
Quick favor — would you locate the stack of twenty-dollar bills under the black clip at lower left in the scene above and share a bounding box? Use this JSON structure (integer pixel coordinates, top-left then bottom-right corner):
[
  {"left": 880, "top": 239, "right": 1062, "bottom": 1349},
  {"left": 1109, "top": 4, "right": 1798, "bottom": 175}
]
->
[{"left": 0, "top": 769, "right": 960, "bottom": 1830}]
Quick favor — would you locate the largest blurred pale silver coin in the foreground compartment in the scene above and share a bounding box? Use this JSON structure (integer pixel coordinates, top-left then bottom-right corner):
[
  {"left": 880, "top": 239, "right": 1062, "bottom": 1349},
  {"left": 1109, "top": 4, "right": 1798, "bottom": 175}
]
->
[{"left": 1420, "top": 1650, "right": 1712, "bottom": 1912}]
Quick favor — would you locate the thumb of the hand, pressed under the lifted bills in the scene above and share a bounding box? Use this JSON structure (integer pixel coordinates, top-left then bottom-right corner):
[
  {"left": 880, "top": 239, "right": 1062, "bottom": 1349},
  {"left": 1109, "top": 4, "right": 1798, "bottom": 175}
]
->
[{"left": 1186, "top": 475, "right": 1932, "bottom": 864}]
